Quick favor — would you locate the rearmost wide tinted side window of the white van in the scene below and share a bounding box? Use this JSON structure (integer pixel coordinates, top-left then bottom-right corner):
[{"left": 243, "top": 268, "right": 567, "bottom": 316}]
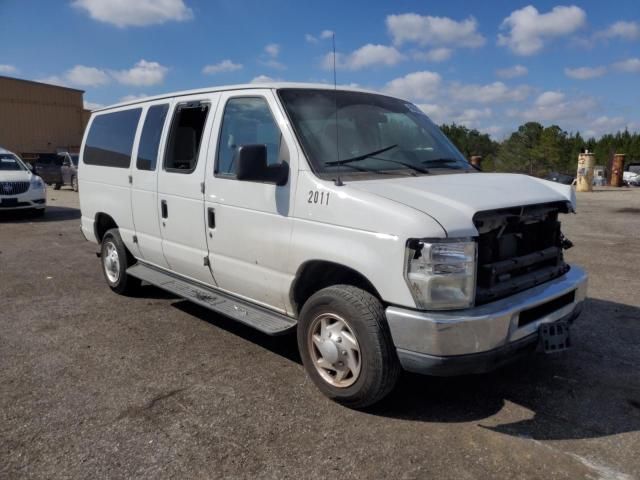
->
[{"left": 83, "top": 108, "right": 142, "bottom": 168}]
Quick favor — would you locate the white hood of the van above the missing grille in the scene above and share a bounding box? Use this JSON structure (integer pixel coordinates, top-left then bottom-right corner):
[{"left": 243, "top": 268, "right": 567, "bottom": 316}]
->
[{"left": 348, "top": 172, "right": 575, "bottom": 237}]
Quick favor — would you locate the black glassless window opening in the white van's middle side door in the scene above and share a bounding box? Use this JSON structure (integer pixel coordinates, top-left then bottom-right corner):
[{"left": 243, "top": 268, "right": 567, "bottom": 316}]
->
[{"left": 164, "top": 102, "right": 209, "bottom": 173}]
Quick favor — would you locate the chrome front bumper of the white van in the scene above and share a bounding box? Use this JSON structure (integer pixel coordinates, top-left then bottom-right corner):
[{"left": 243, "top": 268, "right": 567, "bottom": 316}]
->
[{"left": 386, "top": 266, "right": 587, "bottom": 376}]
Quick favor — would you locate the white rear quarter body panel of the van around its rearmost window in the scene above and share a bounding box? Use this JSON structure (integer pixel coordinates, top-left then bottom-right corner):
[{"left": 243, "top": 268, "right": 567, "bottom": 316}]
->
[{"left": 78, "top": 105, "right": 139, "bottom": 252}]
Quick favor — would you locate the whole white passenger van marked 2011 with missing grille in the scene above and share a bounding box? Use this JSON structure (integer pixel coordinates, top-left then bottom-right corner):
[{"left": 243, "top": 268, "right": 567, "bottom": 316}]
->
[{"left": 78, "top": 83, "right": 587, "bottom": 407}]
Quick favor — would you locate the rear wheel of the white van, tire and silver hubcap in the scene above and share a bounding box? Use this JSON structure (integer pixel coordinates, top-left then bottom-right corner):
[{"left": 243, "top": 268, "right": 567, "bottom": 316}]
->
[{"left": 100, "top": 228, "right": 141, "bottom": 295}]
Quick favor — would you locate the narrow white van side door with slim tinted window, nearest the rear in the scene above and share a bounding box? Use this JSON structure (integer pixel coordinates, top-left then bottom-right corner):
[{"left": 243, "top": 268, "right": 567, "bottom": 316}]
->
[{"left": 131, "top": 100, "right": 171, "bottom": 268}]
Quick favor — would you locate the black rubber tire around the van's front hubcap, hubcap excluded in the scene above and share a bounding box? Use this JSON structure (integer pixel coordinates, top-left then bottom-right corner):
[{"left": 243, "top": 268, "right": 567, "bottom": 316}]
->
[{"left": 298, "top": 285, "right": 401, "bottom": 408}]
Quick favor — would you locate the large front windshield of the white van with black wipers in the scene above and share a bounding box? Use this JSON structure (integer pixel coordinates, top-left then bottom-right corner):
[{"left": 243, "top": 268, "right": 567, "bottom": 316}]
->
[{"left": 278, "top": 88, "right": 473, "bottom": 176}]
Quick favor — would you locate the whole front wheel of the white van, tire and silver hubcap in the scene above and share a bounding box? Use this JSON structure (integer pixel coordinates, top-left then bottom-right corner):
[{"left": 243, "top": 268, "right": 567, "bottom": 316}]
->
[{"left": 298, "top": 285, "right": 400, "bottom": 408}]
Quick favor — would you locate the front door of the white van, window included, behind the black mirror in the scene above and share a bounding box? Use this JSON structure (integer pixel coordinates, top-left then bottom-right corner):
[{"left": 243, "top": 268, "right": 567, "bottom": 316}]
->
[{"left": 205, "top": 89, "right": 297, "bottom": 312}]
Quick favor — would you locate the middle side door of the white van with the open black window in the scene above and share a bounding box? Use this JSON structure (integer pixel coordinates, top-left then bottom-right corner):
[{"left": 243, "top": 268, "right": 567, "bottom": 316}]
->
[{"left": 156, "top": 93, "right": 219, "bottom": 284}]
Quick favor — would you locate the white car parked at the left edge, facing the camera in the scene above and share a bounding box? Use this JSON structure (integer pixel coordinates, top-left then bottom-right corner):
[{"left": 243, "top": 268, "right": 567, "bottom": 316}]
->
[{"left": 0, "top": 148, "right": 47, "bottom": 215}]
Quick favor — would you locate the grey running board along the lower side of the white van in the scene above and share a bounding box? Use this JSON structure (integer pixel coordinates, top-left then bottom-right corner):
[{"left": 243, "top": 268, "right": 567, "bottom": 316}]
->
[{"left": 127, "top": 263, "right": 297, "bottom": 335}]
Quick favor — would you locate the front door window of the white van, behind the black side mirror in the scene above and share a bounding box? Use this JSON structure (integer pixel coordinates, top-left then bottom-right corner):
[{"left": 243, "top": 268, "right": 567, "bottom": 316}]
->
[{"left": 215, "top": 97, "right": 282, "bottom": 175}]
